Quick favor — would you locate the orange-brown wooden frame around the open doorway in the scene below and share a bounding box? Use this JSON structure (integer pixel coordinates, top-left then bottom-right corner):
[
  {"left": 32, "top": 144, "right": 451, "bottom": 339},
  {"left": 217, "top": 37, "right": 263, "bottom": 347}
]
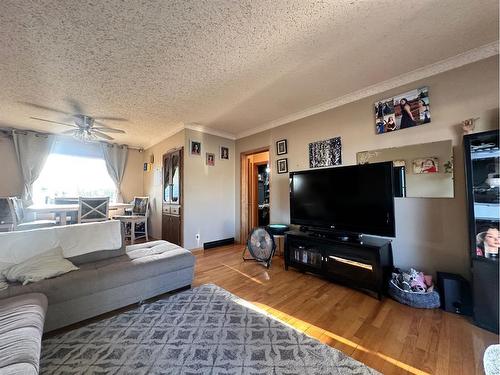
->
[{"left": 240, "top": 146, "right": 272, "bottom": 244}]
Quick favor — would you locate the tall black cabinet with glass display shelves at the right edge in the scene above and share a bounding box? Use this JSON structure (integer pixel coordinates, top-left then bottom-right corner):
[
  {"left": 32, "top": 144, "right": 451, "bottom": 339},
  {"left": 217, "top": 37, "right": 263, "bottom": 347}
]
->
[{"left": 464, "top": 130, "right": 500, "bottom": 332}]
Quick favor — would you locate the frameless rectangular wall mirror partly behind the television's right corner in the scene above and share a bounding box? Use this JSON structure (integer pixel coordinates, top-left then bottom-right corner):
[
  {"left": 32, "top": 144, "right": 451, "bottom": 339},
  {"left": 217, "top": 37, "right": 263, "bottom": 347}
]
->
[{"left": 356, "top": 140, "right": 455, "bottom": 198}]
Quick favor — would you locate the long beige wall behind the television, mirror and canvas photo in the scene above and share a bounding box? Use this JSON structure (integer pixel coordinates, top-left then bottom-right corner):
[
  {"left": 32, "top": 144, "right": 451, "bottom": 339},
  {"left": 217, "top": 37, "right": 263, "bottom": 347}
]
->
[{"left": 235, "top": 56, "right": 499, "bottom": 277}]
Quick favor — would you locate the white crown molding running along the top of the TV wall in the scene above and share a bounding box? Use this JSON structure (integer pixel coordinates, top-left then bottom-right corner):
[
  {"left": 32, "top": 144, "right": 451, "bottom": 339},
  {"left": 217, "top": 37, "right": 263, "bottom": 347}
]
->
[{"left": 236, "top": 40, "right": 499, "bottom": 139}]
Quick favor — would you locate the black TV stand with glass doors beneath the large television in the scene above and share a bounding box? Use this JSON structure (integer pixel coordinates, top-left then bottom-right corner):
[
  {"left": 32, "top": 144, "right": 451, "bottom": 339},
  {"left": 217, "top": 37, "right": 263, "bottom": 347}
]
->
[{"left": 285, "top": 231, "right": 393, "bottom": 299}]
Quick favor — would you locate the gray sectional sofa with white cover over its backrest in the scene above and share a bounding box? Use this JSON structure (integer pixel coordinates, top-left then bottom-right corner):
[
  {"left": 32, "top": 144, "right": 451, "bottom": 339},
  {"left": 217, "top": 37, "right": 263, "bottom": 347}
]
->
[{"left": 0, "top": 221, "right": 194, "bottom": 373}]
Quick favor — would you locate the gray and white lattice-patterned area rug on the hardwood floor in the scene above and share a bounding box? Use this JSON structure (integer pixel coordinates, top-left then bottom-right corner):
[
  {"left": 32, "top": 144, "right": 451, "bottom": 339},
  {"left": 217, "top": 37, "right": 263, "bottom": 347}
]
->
[{"left": 40, "top": 284, "right": 377, "bottom": 375}]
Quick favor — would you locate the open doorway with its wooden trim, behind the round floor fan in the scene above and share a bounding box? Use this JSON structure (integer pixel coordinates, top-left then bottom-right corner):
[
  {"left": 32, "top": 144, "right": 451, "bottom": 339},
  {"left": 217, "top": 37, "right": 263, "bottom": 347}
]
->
[{"left": 240, "top": 148, "right": 271, "bottom": 244}]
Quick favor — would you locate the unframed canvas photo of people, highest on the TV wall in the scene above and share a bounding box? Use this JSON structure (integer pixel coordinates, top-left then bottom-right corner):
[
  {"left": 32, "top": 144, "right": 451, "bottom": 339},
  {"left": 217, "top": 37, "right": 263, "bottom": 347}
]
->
[{"left": 374, "top": 87, "right": 431, "bottom": 134}]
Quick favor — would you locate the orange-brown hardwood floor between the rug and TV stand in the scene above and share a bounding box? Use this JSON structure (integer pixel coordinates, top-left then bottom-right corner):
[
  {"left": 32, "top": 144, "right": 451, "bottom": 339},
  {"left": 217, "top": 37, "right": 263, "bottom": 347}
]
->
[{"left": 194, "top": 245, "right": 499, "bottom": 375}]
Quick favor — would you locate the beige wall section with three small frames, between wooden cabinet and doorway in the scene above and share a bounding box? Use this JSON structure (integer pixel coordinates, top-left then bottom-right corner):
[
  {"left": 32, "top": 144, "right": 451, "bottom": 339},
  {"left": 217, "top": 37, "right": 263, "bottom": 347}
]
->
[{"left": 184, "top": 130, "right": 236, "bottom": 249}]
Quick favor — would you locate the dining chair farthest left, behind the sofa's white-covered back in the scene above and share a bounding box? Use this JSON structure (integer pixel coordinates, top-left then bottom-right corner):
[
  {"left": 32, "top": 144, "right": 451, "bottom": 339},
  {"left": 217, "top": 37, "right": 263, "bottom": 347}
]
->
[{"left": 0, "top": 197, "right": 57, "bottom": 231}]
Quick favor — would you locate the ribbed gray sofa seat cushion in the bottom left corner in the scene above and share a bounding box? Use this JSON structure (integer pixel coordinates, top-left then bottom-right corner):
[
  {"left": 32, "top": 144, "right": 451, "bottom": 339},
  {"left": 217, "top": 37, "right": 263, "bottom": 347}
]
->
[{"left": 0, "top": 293, "right": 47, "bottom": 374}]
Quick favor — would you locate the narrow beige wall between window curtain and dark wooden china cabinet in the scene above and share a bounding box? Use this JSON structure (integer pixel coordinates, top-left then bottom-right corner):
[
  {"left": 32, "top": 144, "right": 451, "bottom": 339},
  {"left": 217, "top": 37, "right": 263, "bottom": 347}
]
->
[{"left": 143, "top": 130, "right": 185, "bottom": 239}]
